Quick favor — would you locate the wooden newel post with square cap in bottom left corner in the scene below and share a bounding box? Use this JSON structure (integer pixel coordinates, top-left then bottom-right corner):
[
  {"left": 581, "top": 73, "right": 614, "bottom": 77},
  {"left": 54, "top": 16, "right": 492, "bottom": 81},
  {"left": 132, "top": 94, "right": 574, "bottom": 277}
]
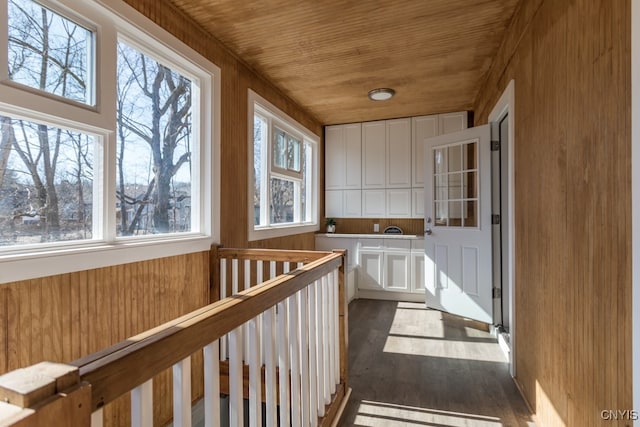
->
[{"left": 0, "top": 362, "right": 91, "bottom": 427}]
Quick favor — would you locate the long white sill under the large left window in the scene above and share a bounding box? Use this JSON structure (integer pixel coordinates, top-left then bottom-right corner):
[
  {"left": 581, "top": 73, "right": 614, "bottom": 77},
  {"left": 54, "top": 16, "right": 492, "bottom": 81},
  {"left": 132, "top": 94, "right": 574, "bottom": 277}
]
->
[{"left": 0, "top": 235, "right": 213, "bottom": 284}]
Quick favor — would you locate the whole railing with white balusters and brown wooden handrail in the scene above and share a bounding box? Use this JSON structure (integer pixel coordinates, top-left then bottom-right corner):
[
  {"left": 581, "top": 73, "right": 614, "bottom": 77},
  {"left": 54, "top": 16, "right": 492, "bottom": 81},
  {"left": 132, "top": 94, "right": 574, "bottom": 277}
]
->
[{"left": 0, "top": 248, "right": 348, "bottom": 427}]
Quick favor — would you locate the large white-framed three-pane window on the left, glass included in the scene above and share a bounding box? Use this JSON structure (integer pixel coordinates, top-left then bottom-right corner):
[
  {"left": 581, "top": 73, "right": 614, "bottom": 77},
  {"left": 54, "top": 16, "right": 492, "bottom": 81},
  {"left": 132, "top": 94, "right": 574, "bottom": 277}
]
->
[{"left": 0, "top": 0, "right": 219, "bottom": 281}]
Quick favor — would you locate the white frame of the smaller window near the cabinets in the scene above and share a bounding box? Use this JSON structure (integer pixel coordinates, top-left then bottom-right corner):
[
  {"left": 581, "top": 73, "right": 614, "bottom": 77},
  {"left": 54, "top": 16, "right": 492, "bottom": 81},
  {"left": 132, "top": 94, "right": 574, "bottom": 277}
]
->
[{"left": 247, "top": 89, "right": 320, "bottom": 241}]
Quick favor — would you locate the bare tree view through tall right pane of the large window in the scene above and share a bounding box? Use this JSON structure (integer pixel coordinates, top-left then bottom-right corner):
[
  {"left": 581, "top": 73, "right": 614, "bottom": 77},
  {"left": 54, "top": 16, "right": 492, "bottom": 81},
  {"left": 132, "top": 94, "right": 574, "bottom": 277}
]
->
[{"left": 117, "top": 42, "right": 192, "bottom": 236}]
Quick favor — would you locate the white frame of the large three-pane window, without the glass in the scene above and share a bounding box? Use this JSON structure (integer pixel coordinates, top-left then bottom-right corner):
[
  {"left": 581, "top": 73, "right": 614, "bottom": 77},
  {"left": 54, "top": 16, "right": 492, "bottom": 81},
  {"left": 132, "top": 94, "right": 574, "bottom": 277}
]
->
[{"left": 0, "top": 0, "right": 221, "bottom": 283}]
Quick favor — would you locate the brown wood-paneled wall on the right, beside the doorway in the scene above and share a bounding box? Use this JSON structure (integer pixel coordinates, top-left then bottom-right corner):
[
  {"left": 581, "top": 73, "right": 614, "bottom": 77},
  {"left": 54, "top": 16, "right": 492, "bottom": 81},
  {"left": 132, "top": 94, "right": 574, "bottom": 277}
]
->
[{"left": 475, "top": 0, "right": 637, "bottom": 426}]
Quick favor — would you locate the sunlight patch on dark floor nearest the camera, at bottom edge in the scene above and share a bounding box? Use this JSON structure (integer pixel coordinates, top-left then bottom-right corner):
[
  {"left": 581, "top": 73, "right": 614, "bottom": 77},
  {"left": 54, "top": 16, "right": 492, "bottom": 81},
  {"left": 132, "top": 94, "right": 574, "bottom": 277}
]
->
[{"left": 354, "top": 400, "right": 502, "bottom": 427}]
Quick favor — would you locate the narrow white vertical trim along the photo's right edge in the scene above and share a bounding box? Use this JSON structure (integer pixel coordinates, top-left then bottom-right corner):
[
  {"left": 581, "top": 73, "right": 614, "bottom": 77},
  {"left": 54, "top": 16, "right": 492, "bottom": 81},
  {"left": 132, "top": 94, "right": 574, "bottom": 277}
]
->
[{"left": 631, "top": 1, "right": 640, "bottom": 426}]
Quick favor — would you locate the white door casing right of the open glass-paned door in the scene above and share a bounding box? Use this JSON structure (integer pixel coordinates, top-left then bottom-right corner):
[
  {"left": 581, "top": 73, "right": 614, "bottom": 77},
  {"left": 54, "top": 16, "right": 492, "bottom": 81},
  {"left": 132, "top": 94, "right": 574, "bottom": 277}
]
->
[{"left": 489, "top": 80, "right": 516, "bottom": 378}]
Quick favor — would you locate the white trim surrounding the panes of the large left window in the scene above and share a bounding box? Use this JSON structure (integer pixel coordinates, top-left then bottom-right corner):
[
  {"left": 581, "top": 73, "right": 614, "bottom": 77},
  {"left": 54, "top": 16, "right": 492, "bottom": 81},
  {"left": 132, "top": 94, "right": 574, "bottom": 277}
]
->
[{"left": 0, "top": 0, "right": 221, "bottom": 283}]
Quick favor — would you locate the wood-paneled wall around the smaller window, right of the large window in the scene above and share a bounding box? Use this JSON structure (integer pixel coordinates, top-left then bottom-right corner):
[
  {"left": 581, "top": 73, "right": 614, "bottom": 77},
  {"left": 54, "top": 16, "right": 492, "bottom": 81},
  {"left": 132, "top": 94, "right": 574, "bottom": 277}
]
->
[{"left": 118, "top": 0, "right": 324, "bottom": 249}]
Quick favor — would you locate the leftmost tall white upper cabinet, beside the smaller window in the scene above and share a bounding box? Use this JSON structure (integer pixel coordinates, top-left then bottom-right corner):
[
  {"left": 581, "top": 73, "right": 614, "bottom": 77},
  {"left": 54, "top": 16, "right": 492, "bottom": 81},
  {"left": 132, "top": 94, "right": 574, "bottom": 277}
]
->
[{"left": 325, "top": 123, "right": 362, "bottom": 190}]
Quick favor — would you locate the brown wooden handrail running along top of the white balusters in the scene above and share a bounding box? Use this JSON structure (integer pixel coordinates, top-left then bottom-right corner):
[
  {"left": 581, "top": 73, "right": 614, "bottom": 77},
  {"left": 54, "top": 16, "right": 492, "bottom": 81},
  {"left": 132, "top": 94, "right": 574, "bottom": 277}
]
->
[{"left": 71, "top": 249, "right": 344, "bottom": 411}]
